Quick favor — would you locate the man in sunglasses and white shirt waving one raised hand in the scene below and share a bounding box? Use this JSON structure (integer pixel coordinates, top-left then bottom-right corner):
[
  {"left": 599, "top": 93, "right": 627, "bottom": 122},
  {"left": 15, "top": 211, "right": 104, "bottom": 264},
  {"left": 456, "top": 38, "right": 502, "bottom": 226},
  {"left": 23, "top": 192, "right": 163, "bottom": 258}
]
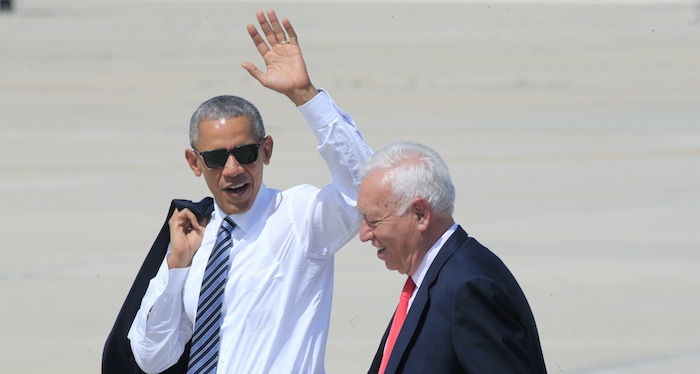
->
[{"left": 115, "top": 11, "right": 372, "bottom": 373}]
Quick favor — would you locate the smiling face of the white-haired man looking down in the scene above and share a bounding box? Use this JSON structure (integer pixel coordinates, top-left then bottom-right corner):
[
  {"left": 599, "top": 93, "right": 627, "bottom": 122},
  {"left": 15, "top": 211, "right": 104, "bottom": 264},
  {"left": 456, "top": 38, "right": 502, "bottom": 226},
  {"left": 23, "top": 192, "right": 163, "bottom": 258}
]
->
[{"left": 357, "top": 173, "right": 429, "bottom": 275}]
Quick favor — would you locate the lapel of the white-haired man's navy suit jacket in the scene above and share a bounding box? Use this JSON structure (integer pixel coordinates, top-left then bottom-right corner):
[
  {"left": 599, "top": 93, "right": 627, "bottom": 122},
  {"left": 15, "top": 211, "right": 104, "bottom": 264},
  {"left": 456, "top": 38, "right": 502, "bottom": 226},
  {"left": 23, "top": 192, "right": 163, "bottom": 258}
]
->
[{"left": 382, "top": 226, "right": 468, "bottom": 373}]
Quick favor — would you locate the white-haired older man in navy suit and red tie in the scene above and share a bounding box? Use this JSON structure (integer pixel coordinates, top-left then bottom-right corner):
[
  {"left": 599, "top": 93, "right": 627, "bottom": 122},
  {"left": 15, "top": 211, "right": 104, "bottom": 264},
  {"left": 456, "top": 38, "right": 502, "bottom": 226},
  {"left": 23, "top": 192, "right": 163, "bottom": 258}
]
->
[{"left": 358, "top": 142, "right": 546, "bottom": 373}]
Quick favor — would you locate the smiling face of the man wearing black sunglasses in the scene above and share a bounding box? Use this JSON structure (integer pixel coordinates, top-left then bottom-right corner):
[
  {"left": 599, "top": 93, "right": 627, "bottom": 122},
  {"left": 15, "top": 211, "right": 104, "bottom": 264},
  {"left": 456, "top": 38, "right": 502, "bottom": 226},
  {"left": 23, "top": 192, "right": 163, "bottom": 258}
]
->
[{"left": 185, "top": 117, "right": 273, "bottom": 214}]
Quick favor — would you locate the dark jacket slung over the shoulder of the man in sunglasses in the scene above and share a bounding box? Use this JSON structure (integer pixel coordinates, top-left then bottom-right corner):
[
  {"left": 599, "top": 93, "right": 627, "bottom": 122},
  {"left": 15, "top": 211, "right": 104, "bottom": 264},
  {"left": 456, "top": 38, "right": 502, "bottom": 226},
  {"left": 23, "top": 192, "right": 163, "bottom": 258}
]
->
[{"left": 102, "top": 197, "right": 214, "bottom": 374}]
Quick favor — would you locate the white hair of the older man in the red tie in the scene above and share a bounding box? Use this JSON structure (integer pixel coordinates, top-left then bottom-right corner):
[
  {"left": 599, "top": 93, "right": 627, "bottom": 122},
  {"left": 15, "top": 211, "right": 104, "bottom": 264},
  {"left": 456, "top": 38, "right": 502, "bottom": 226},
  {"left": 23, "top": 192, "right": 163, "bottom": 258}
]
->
[{"left": 362, "top": 141, "right": 455, "bottom": 216}]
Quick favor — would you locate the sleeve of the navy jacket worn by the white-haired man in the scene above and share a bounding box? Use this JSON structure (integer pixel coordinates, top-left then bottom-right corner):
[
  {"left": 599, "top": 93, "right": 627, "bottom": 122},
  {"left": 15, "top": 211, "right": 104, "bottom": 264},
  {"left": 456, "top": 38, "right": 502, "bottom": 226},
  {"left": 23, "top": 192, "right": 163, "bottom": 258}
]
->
[{"left": 452, "top": 277, "right": 534, "bottom": 373}]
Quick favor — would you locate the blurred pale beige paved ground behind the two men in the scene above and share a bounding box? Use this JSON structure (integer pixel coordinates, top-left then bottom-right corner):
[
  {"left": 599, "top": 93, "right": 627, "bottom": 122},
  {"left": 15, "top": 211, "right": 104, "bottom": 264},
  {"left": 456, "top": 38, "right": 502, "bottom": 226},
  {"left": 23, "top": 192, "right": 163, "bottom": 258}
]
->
[{"left": 0, "top": 0, "right": 700, "bottom": 373}]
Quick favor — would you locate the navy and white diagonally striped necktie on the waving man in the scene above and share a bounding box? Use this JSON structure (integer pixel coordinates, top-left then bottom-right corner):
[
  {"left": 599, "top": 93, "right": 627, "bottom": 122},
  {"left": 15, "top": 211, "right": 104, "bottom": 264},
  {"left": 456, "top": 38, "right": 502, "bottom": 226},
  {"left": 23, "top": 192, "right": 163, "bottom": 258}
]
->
[{"left": 187, "top": 217, "right": 236, "bottom": 374}]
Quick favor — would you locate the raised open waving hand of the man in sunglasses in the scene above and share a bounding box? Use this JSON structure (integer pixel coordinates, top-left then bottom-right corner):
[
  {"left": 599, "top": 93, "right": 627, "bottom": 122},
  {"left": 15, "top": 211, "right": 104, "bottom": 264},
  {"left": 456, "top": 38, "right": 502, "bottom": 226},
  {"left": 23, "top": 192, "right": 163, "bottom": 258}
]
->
[{"left": 241, "top": 10, "right": 318, "bottom": 106}]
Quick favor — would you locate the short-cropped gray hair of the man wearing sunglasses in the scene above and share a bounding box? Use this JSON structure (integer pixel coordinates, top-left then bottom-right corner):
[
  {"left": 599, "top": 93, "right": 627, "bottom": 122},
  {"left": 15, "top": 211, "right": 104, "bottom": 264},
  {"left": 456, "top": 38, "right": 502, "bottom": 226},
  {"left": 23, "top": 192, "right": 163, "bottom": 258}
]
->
[{"left": 190, "top": 95, "right": 265, "bottom": 148}]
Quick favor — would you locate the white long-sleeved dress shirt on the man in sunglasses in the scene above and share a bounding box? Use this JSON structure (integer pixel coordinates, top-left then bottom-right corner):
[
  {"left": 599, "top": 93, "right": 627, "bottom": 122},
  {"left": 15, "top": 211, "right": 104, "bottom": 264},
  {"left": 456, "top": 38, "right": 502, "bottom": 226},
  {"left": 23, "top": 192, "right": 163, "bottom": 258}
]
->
[{"left": 128, "top": 90, "right": 372, "bottom": 374}]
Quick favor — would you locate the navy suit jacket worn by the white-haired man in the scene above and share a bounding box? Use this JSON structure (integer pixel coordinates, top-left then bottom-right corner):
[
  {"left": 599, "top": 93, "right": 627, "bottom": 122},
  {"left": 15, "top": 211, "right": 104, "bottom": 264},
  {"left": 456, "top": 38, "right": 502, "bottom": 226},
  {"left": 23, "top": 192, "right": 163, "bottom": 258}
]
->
[{"left": 369, "top": 227, "right": 547, "bottom": 374}]
